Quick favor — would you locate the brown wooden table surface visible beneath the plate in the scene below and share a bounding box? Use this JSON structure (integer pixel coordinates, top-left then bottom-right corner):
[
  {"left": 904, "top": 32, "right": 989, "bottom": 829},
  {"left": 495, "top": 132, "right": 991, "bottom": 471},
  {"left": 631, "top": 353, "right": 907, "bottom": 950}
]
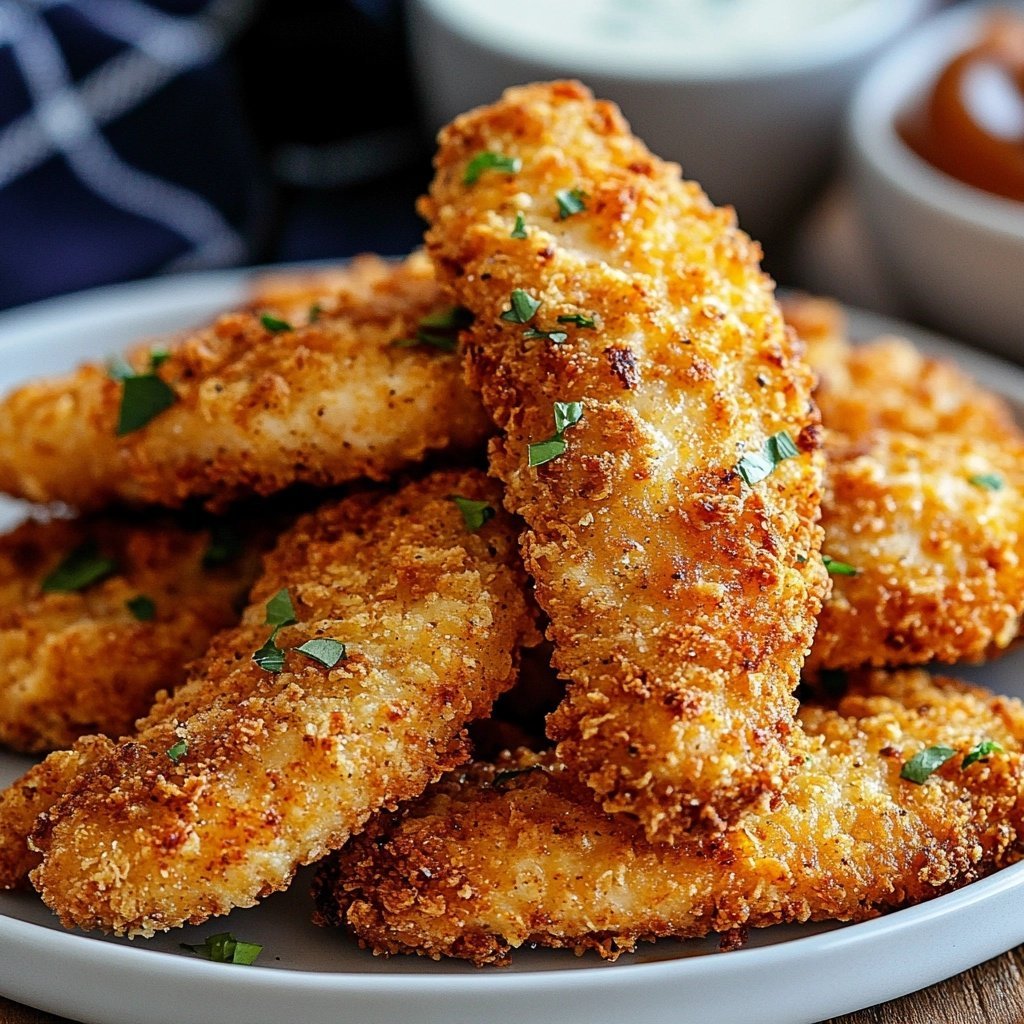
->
[{"left": 0, "top": 946, "right": 1024, "bottom": 1024}]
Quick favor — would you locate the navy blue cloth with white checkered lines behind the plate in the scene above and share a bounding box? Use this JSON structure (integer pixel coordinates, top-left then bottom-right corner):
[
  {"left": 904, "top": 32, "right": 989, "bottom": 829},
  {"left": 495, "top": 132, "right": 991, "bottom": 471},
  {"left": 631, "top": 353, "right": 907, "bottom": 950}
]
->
[{"left": 0, "top": 0, "right": 268, "bottom": 307}]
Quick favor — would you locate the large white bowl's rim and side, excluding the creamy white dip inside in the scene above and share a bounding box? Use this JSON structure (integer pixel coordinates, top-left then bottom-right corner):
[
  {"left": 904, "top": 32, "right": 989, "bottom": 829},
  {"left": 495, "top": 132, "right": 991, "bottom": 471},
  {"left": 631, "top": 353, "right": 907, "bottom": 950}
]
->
[{"left": 409, "top": 0, "right": 933, "bottom": 241}]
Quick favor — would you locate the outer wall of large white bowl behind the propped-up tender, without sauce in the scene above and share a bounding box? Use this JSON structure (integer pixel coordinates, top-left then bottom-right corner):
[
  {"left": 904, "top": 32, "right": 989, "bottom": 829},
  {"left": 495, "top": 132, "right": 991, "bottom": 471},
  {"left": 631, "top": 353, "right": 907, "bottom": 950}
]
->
[{"left": 410, "top": 0, "right": 930, "bottom": 240}]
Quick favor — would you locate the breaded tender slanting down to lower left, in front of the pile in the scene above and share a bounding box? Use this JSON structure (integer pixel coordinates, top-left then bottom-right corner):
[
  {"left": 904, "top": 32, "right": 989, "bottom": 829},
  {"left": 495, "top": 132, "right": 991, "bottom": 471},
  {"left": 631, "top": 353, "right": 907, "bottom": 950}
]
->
[{"left": 25, "top": 471, "right": 536, "bottom": 935}]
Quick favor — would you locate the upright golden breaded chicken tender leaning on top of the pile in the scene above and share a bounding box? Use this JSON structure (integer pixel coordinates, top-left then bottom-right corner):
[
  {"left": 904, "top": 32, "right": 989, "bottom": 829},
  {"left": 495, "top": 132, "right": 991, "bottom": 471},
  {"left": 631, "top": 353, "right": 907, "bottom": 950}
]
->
[{"left": 421, "top": 75, "right": 826, "bottom": 841}]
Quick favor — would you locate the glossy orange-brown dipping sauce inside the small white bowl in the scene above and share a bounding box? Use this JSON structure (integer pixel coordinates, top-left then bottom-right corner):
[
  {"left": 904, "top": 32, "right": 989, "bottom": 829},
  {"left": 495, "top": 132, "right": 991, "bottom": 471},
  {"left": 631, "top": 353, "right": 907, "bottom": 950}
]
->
[{"left": 896, "top": 11, "right": 1024, "bottom": 201}]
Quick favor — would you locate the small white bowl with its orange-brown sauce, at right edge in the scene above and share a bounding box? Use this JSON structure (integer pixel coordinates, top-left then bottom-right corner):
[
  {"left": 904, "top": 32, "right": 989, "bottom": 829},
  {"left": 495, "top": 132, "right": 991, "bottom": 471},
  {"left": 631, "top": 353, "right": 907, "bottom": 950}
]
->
[{"left": 848, "top": 0, "right": 1024, "bottom": 359}]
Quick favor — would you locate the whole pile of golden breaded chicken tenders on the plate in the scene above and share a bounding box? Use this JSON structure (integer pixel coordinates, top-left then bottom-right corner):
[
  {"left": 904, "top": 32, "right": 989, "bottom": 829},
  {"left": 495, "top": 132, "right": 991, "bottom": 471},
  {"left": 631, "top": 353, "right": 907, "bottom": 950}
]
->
[{"left": 0, "top": 82, "right": 1024, "bottom": 965}]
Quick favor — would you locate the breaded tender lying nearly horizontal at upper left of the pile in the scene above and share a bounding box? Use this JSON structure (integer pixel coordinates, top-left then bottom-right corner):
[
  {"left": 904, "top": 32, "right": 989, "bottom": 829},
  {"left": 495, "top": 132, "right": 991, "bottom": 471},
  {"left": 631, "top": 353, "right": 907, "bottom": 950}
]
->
[{"left": 0, "top": 255, "right": 488, "bottom": 508}]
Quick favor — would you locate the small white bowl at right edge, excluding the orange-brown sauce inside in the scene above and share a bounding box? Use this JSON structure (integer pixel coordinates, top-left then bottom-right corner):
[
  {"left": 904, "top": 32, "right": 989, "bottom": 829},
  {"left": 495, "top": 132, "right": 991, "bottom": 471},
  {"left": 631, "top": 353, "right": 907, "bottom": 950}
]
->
[{"left": 848, "top": 0, "right": 1024, "bottom": 360}]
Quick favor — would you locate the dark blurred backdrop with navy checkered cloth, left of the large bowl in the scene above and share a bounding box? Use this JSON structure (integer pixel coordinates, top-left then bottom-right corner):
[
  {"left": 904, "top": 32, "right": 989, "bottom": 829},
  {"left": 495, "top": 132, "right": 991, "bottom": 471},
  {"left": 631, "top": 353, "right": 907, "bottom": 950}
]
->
[{"left": 0, "top": 0, "right": 430, "bottom": 308}]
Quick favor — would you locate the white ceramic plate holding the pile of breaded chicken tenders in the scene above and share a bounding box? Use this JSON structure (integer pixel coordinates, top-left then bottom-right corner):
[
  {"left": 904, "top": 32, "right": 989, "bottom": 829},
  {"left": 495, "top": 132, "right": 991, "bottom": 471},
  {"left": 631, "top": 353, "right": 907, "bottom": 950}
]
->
[{"left": 0, "top": 272, "right": 1024, "bottom": 1024}]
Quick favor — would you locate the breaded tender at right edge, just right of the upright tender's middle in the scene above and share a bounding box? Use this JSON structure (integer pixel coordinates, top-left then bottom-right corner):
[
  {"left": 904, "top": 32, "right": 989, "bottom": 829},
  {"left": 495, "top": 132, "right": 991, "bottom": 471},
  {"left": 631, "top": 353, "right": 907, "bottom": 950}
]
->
[{"left": 807, "top": 431, "right": 1024, "bottom": 671}]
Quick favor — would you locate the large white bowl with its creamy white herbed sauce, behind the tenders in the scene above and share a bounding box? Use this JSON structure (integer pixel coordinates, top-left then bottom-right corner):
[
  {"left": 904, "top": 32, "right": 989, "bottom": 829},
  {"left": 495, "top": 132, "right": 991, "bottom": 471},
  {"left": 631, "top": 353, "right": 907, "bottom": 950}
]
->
[{"left": 409, "top": 0, "right": 934, "bottom": 242}]
